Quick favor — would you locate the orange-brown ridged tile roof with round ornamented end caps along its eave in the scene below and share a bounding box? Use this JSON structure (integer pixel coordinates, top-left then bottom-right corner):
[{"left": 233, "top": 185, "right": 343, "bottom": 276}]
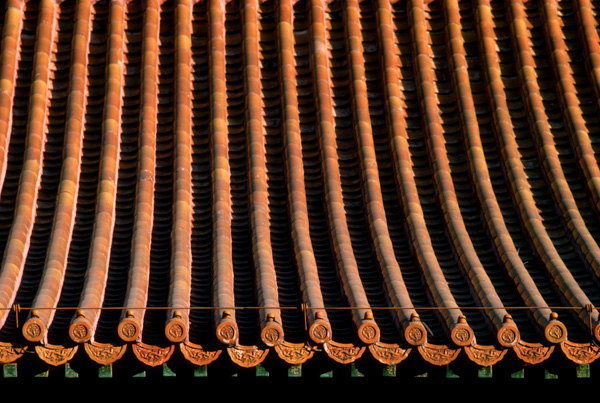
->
[{"left": 0, "top": 0, "right": 600, "bottom": 378}]
